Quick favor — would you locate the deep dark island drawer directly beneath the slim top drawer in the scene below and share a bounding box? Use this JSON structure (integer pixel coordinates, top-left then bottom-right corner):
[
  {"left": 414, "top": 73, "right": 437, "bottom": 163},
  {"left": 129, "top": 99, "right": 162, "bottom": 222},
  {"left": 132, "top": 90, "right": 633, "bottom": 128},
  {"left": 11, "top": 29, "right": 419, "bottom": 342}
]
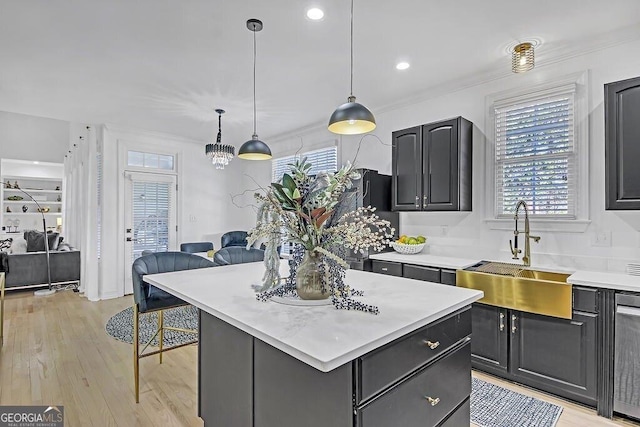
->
[{"left": 358, "top": 342, "right": 471, "bottom": 427}]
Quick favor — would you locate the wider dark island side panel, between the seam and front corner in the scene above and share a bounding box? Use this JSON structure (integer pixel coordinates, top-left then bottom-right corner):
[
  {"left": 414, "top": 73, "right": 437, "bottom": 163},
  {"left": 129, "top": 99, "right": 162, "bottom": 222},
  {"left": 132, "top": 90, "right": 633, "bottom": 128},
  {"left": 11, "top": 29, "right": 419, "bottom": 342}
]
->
[{"left": 254, "top": 339, "right": 354, "bottom": 427}]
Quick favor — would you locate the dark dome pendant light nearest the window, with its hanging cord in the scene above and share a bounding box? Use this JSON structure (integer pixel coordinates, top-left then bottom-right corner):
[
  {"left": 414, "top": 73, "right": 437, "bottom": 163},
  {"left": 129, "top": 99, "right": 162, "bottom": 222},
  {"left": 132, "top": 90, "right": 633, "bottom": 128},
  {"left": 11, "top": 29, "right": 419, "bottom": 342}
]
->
[{"left": 329, "top": 0, "right": 376, "bottom": 135}]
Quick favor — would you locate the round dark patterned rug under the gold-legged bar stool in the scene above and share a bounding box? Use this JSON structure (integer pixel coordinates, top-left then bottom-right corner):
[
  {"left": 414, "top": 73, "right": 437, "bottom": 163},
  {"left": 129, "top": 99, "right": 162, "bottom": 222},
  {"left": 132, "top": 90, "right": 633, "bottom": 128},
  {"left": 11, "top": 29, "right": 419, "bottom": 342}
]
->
[{"left": 105, "top": 305, "right": 198, "bottom": 347}]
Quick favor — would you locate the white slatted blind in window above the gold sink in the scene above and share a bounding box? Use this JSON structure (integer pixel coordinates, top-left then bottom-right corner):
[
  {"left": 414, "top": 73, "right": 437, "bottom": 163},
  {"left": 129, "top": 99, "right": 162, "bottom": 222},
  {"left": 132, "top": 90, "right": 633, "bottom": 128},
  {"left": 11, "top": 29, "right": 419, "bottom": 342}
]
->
[{"left": 494, "top": 85, "right": 577, "bottom": 219}]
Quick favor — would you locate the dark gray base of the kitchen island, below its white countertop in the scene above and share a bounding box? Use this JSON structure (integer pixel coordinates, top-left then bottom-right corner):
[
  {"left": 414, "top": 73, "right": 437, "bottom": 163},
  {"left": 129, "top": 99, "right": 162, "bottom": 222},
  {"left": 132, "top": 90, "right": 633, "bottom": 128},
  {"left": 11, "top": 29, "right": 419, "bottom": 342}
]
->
[{"left": 198, "top": 306, "right": 471, "bottom": 427}]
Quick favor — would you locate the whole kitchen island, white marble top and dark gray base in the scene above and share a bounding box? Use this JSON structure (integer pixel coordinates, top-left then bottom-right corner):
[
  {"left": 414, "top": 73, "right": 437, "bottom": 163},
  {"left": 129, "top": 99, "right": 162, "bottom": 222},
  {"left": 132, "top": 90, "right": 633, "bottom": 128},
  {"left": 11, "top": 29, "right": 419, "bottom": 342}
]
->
[{"left": 145, "top": 261, "right": 483, "bottom": 427}]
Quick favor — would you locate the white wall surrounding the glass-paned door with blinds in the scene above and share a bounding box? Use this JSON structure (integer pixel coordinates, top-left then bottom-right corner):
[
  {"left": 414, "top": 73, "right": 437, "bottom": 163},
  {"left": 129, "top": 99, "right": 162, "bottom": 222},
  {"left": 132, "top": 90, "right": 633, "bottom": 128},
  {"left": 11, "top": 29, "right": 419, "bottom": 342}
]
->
[{"left": 98, "top": 125, "right": 256, "bottom": 299}]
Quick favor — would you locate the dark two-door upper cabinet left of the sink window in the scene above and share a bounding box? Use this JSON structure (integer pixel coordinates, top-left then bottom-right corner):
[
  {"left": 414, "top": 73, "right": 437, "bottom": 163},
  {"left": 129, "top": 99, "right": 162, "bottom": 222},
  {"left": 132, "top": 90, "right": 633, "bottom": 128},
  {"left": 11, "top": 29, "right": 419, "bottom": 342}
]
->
[{"left": 392, "top": 117, "right": 473, "bottom": 211}]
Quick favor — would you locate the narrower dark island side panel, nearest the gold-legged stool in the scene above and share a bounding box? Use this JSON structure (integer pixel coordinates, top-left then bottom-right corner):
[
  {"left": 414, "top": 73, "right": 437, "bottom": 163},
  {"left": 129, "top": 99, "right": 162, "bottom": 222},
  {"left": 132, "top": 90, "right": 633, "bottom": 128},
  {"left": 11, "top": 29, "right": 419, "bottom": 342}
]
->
[{"left": 198, "top": 310, "right": 253, "bottom": 427}]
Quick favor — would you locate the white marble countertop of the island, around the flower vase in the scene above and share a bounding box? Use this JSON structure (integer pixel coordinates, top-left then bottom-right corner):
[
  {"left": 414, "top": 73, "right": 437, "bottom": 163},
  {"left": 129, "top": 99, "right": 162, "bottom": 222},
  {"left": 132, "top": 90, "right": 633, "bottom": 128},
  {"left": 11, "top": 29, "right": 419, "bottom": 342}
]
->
[{"left": 144, "top": 260, "right": 483, "bottom": 372}]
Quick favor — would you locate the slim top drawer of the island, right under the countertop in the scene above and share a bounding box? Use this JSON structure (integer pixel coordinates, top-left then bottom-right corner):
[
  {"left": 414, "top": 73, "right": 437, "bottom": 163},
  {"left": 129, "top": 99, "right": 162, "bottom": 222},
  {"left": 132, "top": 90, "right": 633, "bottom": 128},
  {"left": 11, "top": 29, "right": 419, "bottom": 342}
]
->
[{"left": 357, "top": 309, "right": 471, "bottom": 402}]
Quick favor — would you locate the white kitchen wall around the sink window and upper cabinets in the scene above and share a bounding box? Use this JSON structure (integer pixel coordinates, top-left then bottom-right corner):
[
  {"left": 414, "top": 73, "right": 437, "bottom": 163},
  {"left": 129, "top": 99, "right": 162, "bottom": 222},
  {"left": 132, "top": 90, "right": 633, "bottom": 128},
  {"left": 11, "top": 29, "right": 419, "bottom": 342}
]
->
[{"left": 263, "top": 41, "right": 640, "bottom": 271}]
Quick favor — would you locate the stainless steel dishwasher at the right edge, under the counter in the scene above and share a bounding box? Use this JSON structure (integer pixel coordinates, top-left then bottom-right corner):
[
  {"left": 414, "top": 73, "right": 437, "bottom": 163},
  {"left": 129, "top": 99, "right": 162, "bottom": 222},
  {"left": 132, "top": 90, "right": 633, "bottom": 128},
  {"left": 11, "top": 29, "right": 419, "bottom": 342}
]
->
[{"left": 613, "top": 294, "right": 640, "bottom": 419}]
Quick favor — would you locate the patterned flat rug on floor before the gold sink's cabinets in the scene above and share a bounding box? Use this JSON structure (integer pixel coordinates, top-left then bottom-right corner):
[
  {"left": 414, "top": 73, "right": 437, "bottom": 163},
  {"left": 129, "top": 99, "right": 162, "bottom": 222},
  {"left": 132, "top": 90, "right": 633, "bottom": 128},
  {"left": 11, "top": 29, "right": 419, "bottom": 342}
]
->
[{"left": 471, "top": 378, "right": 562, "bottom": 427}]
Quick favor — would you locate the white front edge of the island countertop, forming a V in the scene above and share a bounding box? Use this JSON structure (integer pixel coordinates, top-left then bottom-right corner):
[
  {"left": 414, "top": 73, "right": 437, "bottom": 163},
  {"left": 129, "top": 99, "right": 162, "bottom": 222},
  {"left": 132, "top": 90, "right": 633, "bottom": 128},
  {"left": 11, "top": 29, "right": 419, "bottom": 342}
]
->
[{"left": 145, "top": 276, "right": 484, "bottom": 372}]
